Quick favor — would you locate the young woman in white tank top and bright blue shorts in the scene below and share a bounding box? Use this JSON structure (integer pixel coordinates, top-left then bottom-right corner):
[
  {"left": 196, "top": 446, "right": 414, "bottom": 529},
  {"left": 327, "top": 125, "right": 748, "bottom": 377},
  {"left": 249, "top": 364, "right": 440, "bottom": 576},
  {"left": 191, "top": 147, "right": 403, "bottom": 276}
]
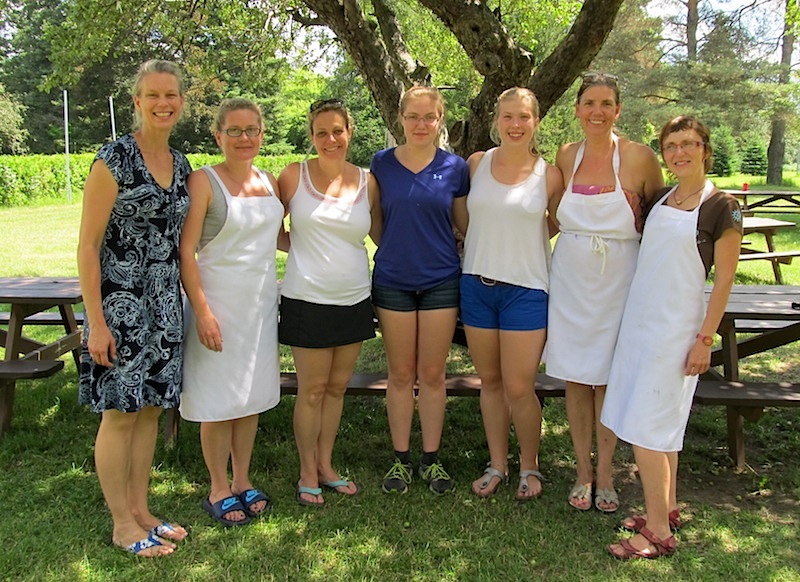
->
[{"left": 461, "top": 87, "right": 562, "bottom": 501}]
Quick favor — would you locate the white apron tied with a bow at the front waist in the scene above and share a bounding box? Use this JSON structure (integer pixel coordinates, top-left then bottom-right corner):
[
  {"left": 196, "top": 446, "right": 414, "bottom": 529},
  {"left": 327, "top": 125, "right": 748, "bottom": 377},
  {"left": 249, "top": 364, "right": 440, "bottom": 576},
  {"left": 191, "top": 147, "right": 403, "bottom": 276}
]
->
[{"left": 544, "top": 135, "right": 640, "bottom": 386}]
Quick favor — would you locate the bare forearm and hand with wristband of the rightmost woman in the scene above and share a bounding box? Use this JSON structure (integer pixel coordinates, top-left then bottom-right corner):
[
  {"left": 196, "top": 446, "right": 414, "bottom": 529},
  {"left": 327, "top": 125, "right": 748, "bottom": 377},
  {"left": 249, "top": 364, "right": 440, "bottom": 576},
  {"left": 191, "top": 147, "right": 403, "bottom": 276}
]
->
[{"left": 684, "top": 228, "right": 742, "bottom": 376}]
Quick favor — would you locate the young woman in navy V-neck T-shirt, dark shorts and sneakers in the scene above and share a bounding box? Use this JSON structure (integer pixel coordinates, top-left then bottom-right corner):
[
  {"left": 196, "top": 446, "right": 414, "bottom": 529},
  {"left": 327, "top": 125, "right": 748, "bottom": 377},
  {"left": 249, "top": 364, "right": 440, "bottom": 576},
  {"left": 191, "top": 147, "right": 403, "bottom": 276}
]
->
[{"left": 370, "top": 86, "right": 469, "bottom": 495}]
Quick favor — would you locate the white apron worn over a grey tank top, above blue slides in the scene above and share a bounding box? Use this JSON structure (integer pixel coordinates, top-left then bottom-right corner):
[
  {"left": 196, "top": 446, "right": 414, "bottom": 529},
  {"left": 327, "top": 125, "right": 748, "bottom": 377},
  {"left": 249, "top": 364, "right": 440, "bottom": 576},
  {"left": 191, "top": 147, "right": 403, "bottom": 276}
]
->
[{"left": 180, "top": 168, "right": 283, "bottom": 422}]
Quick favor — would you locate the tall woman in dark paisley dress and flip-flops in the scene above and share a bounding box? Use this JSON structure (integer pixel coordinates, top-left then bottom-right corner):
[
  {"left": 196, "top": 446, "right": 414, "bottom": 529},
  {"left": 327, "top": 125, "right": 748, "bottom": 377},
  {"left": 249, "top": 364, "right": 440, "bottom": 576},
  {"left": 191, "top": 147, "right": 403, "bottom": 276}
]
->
[{"left": 78, "top": 61, "right": 191, "bottom": 557}]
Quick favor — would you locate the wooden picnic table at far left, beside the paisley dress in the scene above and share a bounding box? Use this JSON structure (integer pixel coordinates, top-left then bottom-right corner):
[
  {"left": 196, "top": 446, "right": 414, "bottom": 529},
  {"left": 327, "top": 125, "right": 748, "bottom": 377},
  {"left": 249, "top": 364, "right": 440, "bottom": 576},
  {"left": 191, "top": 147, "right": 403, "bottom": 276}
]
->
[{"left": 0, "top": 277, "right": 83, "bottom": 434}]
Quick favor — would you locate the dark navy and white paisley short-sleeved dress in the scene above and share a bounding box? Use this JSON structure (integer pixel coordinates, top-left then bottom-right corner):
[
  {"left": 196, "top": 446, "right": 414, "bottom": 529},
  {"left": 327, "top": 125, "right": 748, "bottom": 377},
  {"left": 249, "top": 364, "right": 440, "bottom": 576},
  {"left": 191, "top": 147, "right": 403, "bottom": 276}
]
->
[{"left": 79, "top": 134, "right": 192, "bottom": 412}]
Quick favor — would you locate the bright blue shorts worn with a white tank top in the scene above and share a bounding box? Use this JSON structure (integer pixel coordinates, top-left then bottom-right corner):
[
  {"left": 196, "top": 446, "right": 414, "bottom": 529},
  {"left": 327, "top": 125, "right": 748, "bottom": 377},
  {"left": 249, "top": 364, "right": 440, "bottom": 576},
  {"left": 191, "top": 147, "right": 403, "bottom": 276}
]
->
[{"left": 461, "top": 275, "right": 547, "bottom": 331}]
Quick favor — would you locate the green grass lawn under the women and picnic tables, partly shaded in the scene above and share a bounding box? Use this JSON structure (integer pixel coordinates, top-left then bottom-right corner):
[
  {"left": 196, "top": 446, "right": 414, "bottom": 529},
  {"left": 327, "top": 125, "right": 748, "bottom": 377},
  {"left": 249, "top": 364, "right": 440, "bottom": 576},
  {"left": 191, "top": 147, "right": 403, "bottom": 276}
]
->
[{"left": 0, "top": 198, "right": 800, "bottom": 581}]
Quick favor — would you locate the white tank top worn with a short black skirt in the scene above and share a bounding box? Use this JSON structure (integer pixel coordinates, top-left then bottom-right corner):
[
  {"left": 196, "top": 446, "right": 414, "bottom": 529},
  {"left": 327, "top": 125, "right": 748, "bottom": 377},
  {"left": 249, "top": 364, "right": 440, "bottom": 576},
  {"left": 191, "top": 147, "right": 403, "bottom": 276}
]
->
[{"left": 281, "top": 162, "right": 372, "bottom": 305}]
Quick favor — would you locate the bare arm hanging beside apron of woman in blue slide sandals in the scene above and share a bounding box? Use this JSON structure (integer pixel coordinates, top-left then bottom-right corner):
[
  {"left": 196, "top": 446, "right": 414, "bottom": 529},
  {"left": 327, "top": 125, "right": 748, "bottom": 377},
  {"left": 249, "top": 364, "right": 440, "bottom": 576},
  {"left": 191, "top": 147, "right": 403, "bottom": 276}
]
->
[{"left": 180, "top": 170, "right": 222, "bottom": 352}]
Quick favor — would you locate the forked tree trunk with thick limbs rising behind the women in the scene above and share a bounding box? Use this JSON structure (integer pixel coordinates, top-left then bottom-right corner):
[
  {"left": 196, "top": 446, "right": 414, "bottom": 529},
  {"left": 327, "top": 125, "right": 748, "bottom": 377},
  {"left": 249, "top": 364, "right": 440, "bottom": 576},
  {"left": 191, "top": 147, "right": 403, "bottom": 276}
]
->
[{"left": 303, "top": 0, "right": 623, "bottom": 157}]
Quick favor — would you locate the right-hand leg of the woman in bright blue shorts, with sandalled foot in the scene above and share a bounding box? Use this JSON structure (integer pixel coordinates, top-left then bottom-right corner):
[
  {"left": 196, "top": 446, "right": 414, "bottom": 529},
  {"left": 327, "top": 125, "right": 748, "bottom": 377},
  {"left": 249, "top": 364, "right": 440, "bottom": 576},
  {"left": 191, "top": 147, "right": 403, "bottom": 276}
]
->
[{"left": 500, "top": 329, "right": 545, "bottom": 498}]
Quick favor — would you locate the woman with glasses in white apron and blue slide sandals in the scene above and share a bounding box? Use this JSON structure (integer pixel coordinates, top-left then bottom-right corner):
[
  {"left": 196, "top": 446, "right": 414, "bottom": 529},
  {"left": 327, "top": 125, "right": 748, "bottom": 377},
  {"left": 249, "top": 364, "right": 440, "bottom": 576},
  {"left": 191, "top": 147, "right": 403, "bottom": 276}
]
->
[{"left": 181, "top": 99, "right": 288, "bottom": 526}]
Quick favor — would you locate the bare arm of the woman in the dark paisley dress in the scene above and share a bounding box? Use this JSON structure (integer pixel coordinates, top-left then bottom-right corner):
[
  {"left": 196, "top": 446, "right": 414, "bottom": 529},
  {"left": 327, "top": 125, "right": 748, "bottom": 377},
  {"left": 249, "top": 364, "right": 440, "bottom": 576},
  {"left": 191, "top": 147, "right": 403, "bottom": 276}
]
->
[{"left": 78, "top": 160, "right": 119, "bottom": 367}]
